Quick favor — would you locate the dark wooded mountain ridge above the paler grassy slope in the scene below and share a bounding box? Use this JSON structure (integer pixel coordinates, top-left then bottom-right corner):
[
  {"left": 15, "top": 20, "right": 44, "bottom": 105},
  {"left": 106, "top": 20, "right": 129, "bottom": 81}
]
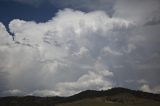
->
[{"left": 0, "top": 87, "right": 160, "bottom": 106}]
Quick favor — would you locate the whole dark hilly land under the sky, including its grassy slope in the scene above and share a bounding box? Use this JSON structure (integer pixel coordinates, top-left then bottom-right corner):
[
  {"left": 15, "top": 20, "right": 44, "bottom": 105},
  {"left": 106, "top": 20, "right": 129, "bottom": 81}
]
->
[{"left": 0, "top": 88, "right": 160, "bottom": 106}]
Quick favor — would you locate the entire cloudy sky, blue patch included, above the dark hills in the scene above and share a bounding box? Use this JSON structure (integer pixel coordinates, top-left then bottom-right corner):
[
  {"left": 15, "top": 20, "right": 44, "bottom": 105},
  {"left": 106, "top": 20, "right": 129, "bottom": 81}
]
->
[{"left": 0, "top": 0, "right": 160, "bottom": 97}]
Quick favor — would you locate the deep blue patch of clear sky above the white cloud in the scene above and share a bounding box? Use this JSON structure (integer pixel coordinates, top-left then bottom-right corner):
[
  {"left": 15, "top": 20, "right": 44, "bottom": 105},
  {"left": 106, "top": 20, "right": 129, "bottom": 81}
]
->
[{"left": 0, "top": 1, "right": 58, "bottom": 25}]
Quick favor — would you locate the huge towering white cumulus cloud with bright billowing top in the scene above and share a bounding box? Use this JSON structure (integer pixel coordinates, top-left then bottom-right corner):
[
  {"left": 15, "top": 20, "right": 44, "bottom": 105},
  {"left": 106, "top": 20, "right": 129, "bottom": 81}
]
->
[{"left": 0, "top": 9, "right": 132, "bottom": 95}]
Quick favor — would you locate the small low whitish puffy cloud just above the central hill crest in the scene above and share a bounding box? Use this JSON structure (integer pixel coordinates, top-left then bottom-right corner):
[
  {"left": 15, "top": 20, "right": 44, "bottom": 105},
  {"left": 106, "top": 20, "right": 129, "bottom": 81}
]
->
[{"left": 56, "top": 71, "right": 113, "bottom": 95}]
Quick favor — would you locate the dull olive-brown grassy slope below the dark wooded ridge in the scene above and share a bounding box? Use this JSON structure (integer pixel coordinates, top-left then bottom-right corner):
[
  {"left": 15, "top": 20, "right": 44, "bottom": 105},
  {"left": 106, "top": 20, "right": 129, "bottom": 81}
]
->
[{"left": 56, "top": 98, "right": 160, "bottom": 106}]
